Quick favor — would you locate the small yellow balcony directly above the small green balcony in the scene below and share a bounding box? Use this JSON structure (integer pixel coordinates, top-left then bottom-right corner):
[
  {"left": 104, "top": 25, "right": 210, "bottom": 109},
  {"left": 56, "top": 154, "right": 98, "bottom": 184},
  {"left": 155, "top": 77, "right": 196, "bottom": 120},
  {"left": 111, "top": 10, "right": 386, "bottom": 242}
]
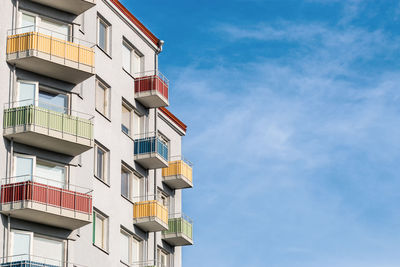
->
[{"left": 162, "top": 157, "right": 193, "bottom": 189}]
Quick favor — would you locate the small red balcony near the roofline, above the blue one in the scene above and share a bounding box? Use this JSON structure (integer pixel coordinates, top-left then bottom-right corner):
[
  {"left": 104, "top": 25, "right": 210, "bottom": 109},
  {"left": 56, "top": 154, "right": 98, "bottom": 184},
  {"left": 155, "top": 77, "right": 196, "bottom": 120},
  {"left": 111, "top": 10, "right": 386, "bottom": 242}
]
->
[{"left": 135, "top": 70, "right": 169, "bottom": 108}]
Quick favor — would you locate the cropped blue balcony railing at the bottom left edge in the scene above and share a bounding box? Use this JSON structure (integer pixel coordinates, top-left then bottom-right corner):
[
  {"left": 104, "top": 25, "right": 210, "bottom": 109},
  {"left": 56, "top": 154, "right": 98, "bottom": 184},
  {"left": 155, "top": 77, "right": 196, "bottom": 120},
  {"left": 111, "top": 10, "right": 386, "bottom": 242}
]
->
[{"left": 0, "top": 254, "right": 87, "bottom": 267}]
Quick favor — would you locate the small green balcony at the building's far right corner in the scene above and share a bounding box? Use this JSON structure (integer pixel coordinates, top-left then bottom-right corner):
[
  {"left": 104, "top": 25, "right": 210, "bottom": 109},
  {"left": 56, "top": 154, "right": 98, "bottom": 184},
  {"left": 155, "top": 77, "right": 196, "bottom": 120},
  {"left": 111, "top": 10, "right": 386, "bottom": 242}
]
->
[{"left": 162, "top": 214, "right": 193, "bottom": 246}]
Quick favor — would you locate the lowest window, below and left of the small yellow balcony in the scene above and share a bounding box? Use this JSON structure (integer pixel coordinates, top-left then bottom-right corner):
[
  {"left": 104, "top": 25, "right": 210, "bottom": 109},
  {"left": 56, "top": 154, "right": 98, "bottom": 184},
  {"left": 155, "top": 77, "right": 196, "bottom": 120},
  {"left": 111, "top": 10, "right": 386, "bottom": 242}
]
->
[{"left": 120, "top": 229, "right": 142, "bottom": 265}]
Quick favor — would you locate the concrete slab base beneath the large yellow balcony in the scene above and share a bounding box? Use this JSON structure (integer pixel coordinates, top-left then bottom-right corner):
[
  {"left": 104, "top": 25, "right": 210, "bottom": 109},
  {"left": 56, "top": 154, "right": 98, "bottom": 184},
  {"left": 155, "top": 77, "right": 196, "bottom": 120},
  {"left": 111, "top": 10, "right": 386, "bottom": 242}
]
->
[{"left": 7, "top": 50, "right": 95, "bottom": 84}]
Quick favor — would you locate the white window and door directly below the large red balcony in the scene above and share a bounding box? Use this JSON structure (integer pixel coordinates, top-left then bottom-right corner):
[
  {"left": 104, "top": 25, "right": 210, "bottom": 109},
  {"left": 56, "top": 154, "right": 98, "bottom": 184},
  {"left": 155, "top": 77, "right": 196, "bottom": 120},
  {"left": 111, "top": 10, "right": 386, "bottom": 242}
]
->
[{"left": 11, "top": 229, "right": 65, "bottom": 266}]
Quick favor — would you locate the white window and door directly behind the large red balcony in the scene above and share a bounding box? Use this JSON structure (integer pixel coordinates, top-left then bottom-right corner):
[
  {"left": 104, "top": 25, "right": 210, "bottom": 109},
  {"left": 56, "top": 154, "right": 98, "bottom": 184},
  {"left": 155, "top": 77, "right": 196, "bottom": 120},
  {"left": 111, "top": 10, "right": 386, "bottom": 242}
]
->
[{"left": 14, "top": 154, "right": 67, "bottom": 188}]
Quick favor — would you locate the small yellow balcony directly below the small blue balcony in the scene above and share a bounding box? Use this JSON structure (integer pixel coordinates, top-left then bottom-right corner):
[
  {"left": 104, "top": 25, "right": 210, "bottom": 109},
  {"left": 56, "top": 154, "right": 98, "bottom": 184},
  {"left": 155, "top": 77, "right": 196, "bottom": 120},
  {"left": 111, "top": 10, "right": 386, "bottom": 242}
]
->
[{"left": 133, "top": 200, "right": 168, "bottom": 232}]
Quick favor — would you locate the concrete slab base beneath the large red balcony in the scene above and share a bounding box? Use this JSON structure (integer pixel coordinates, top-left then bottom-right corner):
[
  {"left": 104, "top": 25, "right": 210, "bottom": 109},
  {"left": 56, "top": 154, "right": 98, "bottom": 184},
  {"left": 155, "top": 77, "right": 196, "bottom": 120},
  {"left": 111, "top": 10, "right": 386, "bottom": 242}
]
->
[{"left": 1, "top": 200, "right": 92, "bottom": 230}]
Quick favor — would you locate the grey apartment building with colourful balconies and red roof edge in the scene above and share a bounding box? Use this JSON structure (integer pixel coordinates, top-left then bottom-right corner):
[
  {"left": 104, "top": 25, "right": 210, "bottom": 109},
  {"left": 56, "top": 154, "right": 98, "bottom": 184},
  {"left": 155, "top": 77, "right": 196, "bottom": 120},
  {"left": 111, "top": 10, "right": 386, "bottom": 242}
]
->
[{"left": 0, "top": 0, "right": 193, "bottom": 267}]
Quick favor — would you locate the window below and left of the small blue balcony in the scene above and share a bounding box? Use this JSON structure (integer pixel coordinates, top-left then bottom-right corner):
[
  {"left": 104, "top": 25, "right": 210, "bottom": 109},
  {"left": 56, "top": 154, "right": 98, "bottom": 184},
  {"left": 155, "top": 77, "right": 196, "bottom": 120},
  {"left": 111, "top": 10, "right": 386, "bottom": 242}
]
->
[{"left": 121, "top": 166, "right": 141, "bottom": 200}]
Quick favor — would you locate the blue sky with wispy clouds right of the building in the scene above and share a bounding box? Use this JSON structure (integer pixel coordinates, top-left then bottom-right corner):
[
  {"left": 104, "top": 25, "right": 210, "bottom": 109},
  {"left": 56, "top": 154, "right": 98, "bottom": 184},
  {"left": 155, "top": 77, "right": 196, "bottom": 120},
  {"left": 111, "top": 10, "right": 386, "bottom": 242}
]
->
[{"left": 122, "top": 0, "right": 400, "bottom": 267}]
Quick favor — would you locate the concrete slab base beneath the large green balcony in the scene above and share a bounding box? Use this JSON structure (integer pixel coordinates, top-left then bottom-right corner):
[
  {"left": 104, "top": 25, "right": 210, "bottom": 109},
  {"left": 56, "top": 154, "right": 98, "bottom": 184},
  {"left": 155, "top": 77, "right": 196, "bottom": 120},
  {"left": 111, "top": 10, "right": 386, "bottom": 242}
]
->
[{"left": 3, "top": 125, "right": 94, "bottom": 156}]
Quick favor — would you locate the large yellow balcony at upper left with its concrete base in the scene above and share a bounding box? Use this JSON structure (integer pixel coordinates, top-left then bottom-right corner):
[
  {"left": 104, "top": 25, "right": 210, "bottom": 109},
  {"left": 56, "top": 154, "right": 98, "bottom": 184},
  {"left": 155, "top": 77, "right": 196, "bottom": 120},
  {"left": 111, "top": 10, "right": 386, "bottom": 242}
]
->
[{"left": 7, "top": 27, "right": 95, "bottom": 84}]
